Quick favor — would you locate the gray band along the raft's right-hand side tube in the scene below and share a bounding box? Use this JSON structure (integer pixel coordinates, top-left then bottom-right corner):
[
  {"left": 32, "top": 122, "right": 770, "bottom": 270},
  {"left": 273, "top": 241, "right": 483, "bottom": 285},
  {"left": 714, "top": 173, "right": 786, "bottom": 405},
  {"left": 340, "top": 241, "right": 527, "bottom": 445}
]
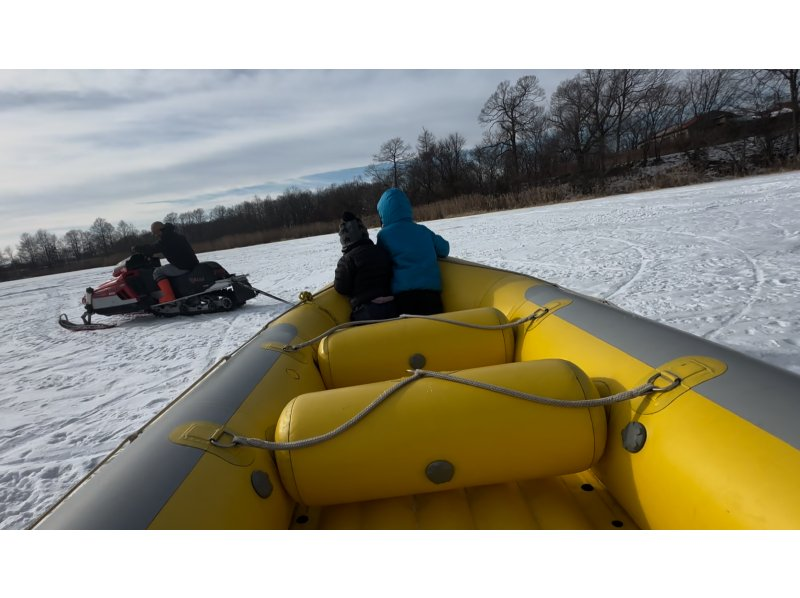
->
[{"left": 525, "top": 283, "right": 800, "bottom": 449}]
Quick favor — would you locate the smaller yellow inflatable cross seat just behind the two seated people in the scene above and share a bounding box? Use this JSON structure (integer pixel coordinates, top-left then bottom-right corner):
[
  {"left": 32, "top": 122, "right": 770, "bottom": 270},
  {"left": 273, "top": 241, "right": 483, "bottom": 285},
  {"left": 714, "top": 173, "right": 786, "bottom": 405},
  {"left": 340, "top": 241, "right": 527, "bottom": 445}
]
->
[{"left": 317, "top": 307, "right": 514, "bottom": 388}]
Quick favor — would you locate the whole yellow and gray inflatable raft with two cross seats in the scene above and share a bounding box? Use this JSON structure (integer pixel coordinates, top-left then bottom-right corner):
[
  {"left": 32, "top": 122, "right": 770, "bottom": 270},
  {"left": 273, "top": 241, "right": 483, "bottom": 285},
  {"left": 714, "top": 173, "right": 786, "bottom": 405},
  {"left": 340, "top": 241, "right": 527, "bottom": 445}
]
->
[{"left": 34, "top": 258, "right": 800, "bottom": 529}]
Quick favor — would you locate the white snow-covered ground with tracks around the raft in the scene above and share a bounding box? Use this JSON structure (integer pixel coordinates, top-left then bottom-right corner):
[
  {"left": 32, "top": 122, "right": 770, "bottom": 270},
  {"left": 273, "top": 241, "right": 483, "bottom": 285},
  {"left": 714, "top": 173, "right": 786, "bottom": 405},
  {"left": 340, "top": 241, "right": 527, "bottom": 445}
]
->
[{"left": 0, "top": 172, "right": 800, "bottom": 530}]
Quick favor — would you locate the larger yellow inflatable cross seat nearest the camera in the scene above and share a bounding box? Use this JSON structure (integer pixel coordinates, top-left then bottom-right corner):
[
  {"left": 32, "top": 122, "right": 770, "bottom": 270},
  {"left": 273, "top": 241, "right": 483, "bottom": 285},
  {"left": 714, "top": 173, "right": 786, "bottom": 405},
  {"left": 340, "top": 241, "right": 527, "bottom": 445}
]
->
[{"left": 275, "top": 359, "right": 606, "bottom": 506}]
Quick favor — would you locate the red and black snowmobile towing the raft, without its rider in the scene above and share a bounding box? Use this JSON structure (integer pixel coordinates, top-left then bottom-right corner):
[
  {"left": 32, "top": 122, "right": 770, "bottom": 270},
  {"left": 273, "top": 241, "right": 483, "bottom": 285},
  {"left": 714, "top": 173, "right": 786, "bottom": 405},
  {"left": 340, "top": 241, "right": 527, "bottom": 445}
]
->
[{"left": 59, "top": 253, "right": 276, "bottom": 330}]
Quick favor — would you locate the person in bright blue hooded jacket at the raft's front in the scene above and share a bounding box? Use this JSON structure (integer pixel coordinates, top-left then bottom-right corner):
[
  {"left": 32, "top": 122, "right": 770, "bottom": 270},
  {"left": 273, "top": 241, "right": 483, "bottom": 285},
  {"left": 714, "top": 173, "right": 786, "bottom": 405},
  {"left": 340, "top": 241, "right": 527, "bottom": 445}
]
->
[{"left": 377, "top": 188, "right": 450, "bottom": 315}]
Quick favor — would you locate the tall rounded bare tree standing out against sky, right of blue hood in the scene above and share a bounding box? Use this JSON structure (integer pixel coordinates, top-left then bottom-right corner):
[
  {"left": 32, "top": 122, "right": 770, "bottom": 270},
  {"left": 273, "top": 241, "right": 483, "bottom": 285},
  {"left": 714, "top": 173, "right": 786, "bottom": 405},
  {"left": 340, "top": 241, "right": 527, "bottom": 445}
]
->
[{"left": 478, "top": 75, "right": 545, "bottom": 182}]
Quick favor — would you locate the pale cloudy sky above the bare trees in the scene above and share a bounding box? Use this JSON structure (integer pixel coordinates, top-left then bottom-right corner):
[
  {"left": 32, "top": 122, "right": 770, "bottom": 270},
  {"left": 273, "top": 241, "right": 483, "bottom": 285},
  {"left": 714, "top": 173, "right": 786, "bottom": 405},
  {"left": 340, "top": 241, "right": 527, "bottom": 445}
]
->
[{"left": 0, "top": 69, "right": 577, "bottom": 248}]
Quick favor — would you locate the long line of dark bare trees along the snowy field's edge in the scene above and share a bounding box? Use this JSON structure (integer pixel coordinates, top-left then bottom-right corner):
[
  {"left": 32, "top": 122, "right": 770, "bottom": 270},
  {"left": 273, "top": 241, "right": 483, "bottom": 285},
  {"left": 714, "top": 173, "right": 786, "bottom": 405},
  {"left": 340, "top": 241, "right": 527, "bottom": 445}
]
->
[{"left": 0, "top": 69, "right": 800, "bottom": 278}]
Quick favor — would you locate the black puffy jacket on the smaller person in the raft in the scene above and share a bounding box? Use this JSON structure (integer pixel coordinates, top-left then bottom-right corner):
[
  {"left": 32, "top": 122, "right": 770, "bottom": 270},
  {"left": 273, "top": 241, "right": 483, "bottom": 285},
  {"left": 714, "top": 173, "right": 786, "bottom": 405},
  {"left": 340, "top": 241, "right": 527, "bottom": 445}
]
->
[{"left": 333, "top": 239, "right": 392, "bottom": 309}]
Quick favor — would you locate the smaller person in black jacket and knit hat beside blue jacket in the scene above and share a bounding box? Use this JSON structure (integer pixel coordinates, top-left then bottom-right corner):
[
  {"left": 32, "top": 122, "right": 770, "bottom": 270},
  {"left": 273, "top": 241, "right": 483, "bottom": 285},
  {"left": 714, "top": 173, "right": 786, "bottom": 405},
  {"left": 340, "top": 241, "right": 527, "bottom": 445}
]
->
[{"left": 333, "top": 212, "right": 397, "bottom": 321}]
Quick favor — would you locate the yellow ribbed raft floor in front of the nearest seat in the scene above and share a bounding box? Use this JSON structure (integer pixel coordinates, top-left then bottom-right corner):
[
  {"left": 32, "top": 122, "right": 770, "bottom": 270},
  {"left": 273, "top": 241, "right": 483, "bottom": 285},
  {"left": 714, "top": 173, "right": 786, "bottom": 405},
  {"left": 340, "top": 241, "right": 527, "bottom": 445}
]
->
[{"left": 290, "top": 471, "right": 638, "bottom": 530}]
